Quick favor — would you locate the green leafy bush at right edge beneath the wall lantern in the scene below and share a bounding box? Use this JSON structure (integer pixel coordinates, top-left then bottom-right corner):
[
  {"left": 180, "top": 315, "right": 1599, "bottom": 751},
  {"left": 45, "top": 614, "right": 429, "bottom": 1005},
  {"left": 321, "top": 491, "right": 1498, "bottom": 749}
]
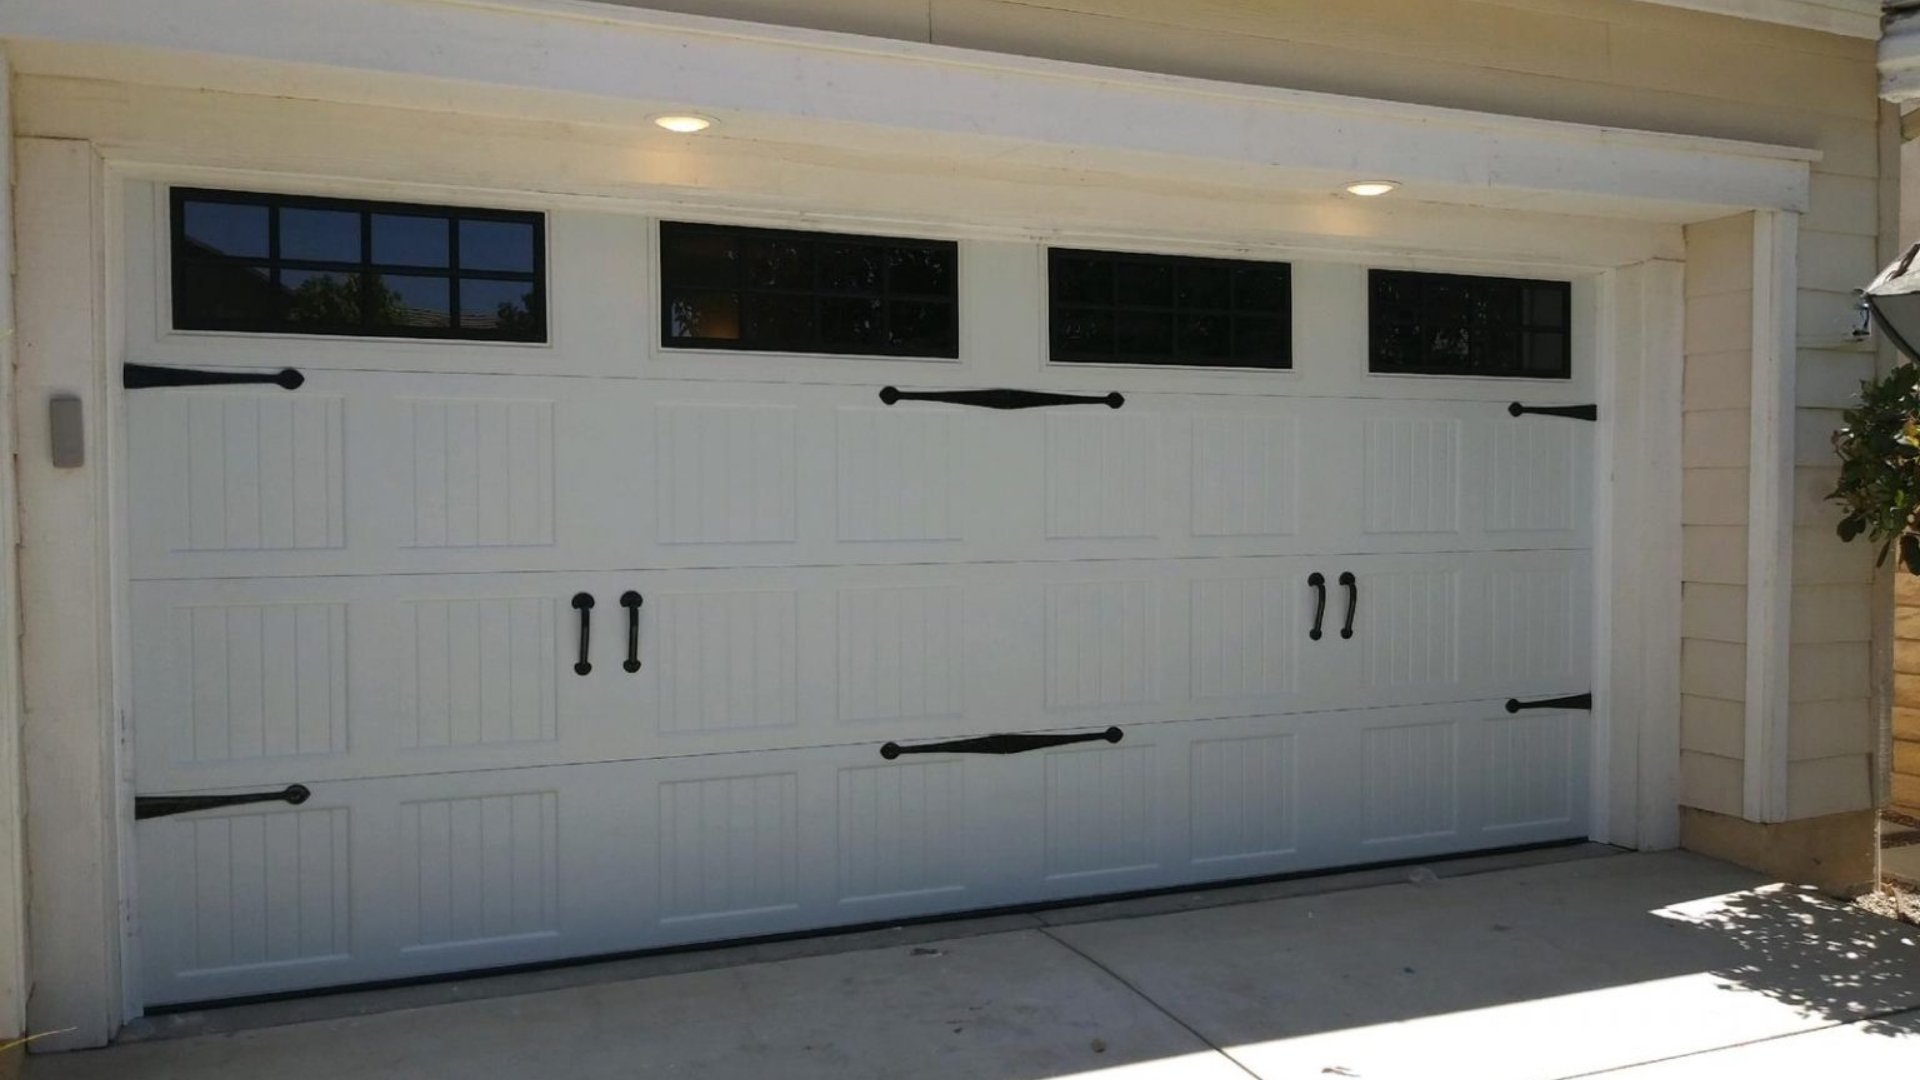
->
[{"left": 1828, "top": 363, "right": 1920, "bottom": 575}]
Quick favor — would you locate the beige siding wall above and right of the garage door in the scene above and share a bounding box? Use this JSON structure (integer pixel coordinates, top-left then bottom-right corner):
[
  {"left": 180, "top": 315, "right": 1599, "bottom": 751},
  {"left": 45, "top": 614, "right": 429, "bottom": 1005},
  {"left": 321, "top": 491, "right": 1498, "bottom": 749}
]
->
[{"left": 595, "top": 0, "right": 1899, "bottom": 817}]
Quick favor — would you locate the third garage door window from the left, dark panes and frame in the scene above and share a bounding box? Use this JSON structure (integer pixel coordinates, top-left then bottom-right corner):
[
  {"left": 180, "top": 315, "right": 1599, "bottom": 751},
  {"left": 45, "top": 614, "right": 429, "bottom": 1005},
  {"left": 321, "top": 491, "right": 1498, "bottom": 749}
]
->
[{"left": 1046, "top": 248, "right": 1292, "bottom": 369}]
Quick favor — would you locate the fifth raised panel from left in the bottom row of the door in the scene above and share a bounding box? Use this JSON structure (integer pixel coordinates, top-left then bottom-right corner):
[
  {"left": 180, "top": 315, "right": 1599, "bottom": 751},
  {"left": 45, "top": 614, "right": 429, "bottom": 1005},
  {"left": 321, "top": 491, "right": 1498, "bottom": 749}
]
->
[{"left": 1046, "top": 748, "right": 1160, "bottom": 878}]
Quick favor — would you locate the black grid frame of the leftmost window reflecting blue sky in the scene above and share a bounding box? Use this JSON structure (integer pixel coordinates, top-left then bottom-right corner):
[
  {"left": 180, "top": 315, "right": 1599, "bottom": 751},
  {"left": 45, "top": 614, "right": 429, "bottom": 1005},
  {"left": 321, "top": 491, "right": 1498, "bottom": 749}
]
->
[{"left": 167, "top": 186, "right": 549, "bottom": 344}]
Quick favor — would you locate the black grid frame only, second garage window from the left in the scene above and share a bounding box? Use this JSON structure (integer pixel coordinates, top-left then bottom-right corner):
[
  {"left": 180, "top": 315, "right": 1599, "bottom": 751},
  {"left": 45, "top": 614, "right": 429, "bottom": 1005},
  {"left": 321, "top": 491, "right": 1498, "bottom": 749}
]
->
[{"left": 655, "top": 221, "right": 960, "bottom": 359}]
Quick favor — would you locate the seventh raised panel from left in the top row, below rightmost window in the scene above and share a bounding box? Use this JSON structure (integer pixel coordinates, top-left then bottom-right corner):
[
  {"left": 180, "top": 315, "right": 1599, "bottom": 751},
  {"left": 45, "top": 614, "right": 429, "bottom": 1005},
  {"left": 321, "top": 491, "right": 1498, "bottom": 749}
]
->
[{"left": 1361, "top": 417, "right": 1459, "bottom": 532}]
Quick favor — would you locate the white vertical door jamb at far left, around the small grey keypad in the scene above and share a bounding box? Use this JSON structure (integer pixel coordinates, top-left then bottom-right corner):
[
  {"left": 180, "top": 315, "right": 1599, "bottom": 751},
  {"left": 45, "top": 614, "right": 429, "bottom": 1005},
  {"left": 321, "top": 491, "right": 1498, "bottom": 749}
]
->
[{"left": 13, "top": 138, "right": 123, "bottom": 1049}]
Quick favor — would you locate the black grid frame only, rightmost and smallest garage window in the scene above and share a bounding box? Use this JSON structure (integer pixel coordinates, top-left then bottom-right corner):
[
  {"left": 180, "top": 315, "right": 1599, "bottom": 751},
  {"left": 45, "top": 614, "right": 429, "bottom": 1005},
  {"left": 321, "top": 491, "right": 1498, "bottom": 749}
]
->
[{"left": 1367, "top": 267, "right": 1574, "bottom": 382}]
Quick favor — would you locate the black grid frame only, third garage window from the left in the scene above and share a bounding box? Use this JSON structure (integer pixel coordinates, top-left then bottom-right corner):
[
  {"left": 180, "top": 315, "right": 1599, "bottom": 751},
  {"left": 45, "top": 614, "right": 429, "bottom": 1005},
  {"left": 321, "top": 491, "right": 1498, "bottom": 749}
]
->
[{"left": 1046, "top": 248, "right": 1294, "bottom": 371}]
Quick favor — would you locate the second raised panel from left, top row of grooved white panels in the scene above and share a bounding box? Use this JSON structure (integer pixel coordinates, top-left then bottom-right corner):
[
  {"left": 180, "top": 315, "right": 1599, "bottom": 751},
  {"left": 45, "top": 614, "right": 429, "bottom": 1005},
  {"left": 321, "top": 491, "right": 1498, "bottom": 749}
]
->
[{"left": 401, "top": 398, "right": 553, "bottom": 548}]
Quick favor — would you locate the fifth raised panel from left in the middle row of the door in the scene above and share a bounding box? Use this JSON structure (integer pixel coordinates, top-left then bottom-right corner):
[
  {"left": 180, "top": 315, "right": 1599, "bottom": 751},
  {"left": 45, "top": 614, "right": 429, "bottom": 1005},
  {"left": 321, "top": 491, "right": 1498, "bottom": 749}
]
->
[{"left": 1046, "top": 580, "right": 1160, "bottom": 709}]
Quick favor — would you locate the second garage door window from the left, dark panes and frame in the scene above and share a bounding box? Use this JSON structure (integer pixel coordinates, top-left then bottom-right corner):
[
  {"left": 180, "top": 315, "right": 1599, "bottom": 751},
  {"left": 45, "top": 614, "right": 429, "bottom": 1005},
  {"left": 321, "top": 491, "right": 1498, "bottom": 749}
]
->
[{"left": 660, "top": 221, "right": 960, "bottom": 359}]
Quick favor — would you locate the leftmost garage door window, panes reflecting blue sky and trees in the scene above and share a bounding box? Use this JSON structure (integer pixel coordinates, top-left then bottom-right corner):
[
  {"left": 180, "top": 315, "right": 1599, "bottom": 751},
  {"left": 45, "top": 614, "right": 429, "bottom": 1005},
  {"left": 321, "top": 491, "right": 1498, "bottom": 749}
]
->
[{"left": 173, "top": 188, "right": 547, "bottom": 342}]
